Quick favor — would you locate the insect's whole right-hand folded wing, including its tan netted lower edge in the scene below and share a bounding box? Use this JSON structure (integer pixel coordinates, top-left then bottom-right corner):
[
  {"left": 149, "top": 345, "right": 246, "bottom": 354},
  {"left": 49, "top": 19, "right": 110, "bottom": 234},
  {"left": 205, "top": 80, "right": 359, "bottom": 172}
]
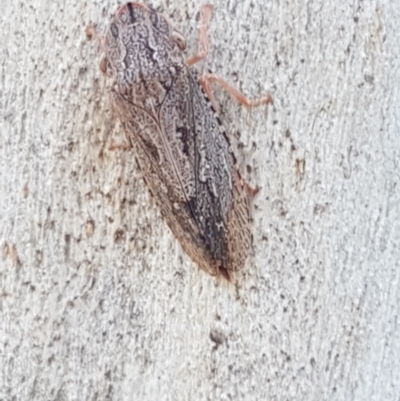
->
[{"left": 185, "top": 70, "right": 251, "bottom": 275}]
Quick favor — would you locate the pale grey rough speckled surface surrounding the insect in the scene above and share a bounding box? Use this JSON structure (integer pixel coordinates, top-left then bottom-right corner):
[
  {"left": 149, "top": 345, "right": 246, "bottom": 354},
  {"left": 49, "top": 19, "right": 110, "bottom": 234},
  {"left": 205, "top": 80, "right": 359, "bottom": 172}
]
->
[{"left": 0, "top": 0, "right": 400, "bottom": 401}]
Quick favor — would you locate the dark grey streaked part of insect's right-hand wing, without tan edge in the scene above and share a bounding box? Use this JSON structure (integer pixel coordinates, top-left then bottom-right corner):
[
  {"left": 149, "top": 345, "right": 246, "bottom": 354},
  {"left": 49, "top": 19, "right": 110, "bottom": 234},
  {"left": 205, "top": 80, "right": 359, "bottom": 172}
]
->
[{"left": 179, "top": 72, "right": 234, "bottom": 270}]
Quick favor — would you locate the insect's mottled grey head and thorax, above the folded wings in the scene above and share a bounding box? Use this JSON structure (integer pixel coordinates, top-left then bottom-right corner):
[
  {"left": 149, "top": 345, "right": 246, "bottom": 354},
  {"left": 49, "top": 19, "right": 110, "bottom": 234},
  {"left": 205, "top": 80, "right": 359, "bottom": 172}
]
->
[{"left": 105, "top": 4, "right": 185, "bottom": 89}]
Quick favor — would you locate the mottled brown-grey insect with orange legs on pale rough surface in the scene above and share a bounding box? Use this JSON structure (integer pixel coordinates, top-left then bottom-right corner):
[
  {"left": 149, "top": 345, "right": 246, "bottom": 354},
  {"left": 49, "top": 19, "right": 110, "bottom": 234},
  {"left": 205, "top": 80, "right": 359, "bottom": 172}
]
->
[{"left": 87, "top": 2, "right": 272, "bottom": 280}]
